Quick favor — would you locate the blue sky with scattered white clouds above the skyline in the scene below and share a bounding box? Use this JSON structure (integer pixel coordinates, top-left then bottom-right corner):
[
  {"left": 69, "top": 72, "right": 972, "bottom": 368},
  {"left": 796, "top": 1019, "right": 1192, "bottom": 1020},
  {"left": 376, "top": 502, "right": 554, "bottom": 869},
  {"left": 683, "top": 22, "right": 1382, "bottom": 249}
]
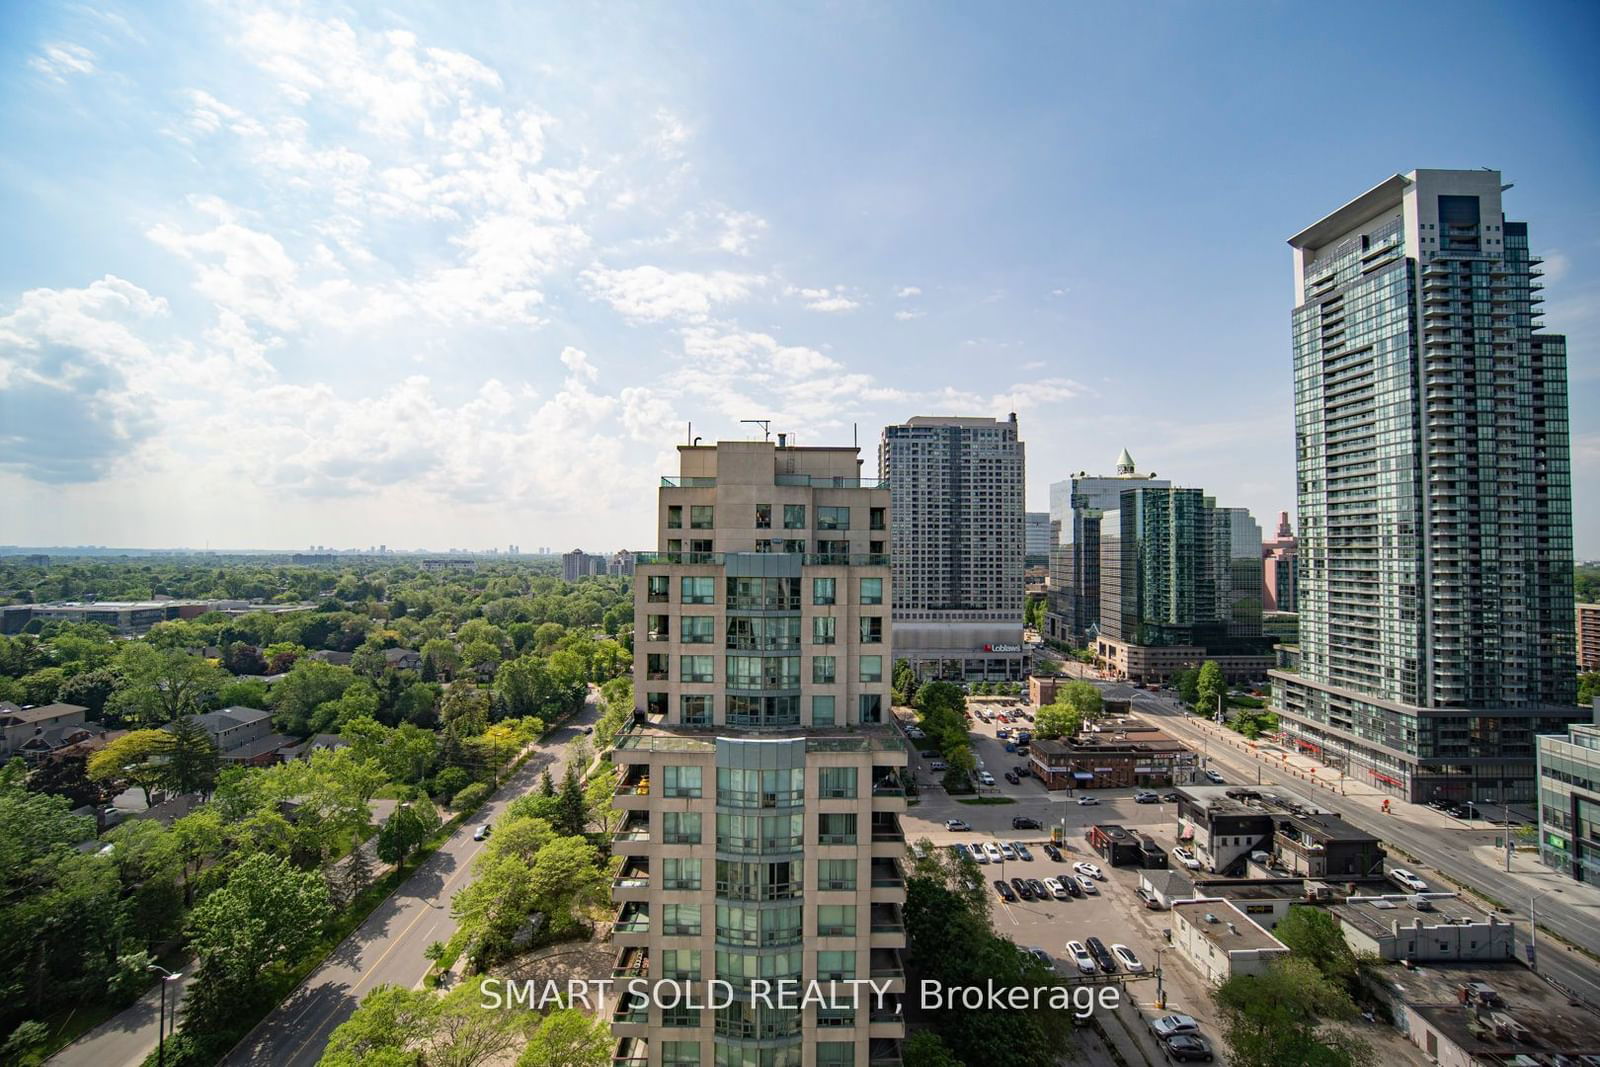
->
[{"left": 0, "top": 2, "right": 1600, "bottom": 557}]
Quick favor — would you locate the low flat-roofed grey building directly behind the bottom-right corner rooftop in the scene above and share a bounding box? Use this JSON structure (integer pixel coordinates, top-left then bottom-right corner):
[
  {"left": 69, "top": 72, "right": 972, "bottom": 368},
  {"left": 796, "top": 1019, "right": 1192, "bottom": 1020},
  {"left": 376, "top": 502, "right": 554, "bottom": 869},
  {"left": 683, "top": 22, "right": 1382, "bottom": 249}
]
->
[{"left": 1328, "top": 893, "right": 1517, "bottom": 963}]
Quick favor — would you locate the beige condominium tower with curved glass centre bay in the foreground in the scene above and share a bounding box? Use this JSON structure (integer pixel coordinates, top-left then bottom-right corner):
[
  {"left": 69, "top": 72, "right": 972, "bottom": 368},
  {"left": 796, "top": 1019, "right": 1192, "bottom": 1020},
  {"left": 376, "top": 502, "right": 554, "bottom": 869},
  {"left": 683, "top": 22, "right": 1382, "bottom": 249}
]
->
[{"left": 611, "top": 435, "right": 906, "bottom": 1067}]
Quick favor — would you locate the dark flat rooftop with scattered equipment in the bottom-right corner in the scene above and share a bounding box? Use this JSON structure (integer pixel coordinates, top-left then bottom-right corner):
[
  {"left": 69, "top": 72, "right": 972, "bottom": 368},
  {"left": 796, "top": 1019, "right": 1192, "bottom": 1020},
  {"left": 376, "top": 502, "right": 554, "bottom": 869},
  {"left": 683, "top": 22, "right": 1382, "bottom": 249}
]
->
[{"left": 1368, "top": 960, "right": 1600, "bottom": 1067}]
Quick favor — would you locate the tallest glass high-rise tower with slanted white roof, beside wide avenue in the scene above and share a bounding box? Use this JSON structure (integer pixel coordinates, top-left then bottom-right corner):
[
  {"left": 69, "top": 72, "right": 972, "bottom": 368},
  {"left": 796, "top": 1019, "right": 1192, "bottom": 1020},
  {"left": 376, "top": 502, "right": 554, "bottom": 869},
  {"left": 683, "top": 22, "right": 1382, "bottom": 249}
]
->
[{"left": 1272, "top": 170, "right": 1586, "bottom": 803}]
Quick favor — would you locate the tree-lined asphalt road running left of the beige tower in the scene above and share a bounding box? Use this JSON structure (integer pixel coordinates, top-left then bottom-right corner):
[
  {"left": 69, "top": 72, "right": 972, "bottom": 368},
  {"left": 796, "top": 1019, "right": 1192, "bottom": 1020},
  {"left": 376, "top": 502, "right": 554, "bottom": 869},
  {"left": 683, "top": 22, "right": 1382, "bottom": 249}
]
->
[{"left": 220, "top": 689, "right": 600, "bottom": 1067}]
